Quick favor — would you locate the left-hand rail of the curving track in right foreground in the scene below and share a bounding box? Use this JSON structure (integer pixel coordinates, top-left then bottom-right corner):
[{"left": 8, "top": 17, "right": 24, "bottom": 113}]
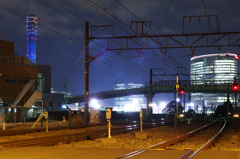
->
[{"left": 116, "top": 119, "right": 218, "bottom": 159}]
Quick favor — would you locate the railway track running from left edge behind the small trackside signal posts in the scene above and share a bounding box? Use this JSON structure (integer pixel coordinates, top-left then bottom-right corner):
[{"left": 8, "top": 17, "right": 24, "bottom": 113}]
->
[{"left": 0, "top": 122, "right": 169, "bottom": 147}]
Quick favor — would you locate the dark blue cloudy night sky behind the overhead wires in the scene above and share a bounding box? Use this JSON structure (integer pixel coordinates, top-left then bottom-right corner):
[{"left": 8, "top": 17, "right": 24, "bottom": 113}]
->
[{"left": 0, "top": 0, "right": 240, "bottom": 105}]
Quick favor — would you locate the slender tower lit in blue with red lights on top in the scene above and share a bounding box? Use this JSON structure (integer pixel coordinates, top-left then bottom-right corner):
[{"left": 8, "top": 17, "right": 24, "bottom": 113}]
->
[{"left": 26, "top": 7, "right": 38, "bottom": 63}]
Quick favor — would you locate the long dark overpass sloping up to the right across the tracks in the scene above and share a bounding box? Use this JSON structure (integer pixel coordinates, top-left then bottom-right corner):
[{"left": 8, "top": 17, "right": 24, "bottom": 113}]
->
[{"left": 67, "top": 80, "right": 233, "bottom": 104}]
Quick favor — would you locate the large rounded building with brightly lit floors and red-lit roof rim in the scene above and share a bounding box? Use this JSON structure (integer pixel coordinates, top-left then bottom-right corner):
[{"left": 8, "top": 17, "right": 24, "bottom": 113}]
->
[{"left": 191, "top": 53, "right": 238, "bottom": 113}]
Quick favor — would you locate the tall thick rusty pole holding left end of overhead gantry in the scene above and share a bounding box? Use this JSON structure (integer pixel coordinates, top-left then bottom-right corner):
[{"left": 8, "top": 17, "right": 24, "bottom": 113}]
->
[{"left": 84, "top": 21, "right": 90, "bottom": 125}]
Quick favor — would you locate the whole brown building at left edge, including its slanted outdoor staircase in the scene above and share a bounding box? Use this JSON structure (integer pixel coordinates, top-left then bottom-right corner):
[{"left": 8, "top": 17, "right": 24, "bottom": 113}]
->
[{"left": 0, "top": 40, "right": 42, "bottom": 121}]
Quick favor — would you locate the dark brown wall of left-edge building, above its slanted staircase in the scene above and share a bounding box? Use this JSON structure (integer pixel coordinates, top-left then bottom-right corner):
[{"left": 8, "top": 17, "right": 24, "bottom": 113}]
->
[{"left": 0, "top": 40, "right": 38, "bottom": 106}]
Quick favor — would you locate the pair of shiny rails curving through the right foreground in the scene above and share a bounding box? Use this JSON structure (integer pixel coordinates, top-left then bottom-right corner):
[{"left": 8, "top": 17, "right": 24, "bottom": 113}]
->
[{"left": 117, "top": 119, "right": 226, "bottom": 159}]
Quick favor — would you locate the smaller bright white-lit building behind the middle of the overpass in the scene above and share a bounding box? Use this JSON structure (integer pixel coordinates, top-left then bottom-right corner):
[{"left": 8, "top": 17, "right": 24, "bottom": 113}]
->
[{"left": 115, "top": 83, "right": 146, "bottom": 112}]
